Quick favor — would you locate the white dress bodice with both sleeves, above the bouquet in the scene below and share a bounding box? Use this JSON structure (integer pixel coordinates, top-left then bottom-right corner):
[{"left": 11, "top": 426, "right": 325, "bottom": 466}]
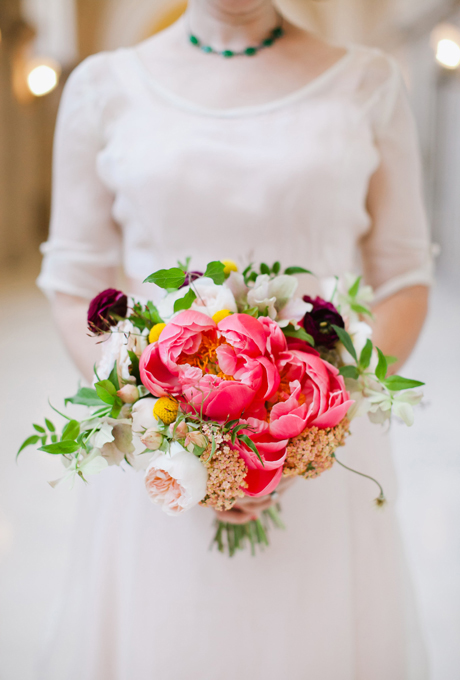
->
[{"left": 39, "top": 46, "right": 431, "bottom": 304}]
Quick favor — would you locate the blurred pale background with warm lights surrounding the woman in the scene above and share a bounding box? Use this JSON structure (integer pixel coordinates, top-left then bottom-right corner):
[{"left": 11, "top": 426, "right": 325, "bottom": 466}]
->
[{"left": 0, "top": 0, "right": 460, "bottom": 680}]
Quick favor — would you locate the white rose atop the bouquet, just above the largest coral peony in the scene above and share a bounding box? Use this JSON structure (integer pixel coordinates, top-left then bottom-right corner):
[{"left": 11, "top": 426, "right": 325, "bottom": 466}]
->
[{"left": 157, "top": 277, "right": 238, "bottom": 322}]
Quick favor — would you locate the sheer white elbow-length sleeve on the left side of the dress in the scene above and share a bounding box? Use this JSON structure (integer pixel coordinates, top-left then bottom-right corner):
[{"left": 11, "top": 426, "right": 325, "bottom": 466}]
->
[{"left": 37, "top": 55, "right": 121, "bottom": 298}]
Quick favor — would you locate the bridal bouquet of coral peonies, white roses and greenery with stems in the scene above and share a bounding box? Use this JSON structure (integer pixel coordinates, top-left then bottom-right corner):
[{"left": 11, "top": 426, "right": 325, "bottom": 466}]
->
[{"left": 18, "top": 260, "right": 423, "bottom": 555}]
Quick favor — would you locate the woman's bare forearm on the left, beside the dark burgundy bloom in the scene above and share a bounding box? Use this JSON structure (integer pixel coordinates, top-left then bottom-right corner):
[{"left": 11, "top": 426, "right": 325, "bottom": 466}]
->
[{"left": 53, "top": 293, "right": 100, "bottom": 383}]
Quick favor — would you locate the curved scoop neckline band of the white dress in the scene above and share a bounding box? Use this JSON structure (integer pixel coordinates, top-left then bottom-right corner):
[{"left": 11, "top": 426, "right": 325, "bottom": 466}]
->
[{"left": 129, "top": 45, "right": 355, "bottom": 118}]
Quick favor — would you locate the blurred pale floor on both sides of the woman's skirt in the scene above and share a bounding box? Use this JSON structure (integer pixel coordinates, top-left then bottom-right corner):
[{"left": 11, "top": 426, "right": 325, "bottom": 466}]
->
[{"left": 0, "top": 266, "right": 460, "bottom": 680}]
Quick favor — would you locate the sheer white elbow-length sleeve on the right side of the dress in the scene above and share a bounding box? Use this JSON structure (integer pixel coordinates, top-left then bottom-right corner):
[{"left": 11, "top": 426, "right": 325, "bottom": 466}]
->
[{"left": 361, "top": 59, "right": 432, "bottom": 300}]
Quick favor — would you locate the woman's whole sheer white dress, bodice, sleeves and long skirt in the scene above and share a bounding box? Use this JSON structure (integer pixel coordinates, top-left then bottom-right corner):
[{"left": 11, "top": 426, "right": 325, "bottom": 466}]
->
[{"left": 39, "top": 42, "right": 431, "bottom": 680}]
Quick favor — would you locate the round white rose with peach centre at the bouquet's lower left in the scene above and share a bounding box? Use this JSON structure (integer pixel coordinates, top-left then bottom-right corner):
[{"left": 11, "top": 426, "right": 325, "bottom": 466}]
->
[{"left": 145, "top": 442, "right": 208, "bottom": 515}]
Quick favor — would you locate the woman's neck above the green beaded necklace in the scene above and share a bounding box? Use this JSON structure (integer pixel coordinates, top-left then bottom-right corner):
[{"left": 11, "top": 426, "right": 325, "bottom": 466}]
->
[{"left": 186, "top": 0, "right": 280, "bottom": 50}]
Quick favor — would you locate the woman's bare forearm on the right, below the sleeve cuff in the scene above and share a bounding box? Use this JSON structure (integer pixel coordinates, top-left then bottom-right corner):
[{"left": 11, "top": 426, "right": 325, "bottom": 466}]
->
[{"left": 373, "top": 286, "right": 428, "bottom": 373}]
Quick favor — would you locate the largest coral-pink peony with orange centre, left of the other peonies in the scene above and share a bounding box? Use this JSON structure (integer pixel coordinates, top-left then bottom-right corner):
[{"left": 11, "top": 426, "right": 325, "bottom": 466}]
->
[{"left": 139, "top": 310, "right": 280, "bottom": 420}]
